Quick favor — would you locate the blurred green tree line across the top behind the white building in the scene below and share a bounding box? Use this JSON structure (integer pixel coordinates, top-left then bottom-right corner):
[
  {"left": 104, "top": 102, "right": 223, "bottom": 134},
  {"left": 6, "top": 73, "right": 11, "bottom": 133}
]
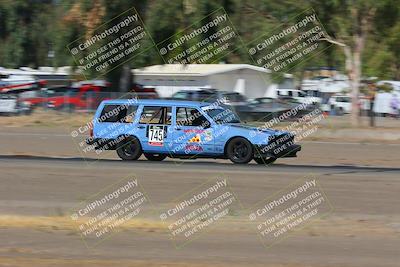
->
[{"left": 0, "top": 0, "right": 400, "bottom": 122}]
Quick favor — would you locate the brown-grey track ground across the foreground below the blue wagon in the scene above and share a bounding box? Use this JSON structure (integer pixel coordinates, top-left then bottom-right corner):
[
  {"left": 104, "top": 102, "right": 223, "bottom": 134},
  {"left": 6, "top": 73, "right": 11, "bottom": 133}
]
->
[{"left": 0, "top": 155, "right": 400, "bottom": 267}]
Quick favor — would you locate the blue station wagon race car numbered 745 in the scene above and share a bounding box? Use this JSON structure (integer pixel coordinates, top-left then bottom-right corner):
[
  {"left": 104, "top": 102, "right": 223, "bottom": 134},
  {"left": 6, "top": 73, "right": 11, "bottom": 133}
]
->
[{"left": 86, "top": 99, "right": 301, "bottom": 164}]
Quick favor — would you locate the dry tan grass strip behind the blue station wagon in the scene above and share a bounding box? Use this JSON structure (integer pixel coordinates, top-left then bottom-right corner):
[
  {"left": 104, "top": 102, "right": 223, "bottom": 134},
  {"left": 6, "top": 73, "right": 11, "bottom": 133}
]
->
[{"left": 0, "top": 110, "right": 400, "bottom": 144}]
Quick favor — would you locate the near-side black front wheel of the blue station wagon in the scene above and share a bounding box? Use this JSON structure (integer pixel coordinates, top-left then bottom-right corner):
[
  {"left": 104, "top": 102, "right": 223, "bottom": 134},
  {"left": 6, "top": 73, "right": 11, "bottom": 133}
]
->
[{"left": 226, "top": 137, "right": 253, "bottom": 164}]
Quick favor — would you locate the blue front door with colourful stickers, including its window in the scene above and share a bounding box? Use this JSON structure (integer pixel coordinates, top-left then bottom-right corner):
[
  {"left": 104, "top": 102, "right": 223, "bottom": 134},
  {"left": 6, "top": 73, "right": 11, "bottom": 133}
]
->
[{"left": 170, "top": 106, "right": 215, "bottom": 156}]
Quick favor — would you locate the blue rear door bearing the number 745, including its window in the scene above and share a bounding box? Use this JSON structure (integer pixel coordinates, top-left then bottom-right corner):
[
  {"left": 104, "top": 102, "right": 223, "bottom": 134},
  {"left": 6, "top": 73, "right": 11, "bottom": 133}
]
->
[{"left": 137, "top": 105, "right": 172, "bottom": 153}]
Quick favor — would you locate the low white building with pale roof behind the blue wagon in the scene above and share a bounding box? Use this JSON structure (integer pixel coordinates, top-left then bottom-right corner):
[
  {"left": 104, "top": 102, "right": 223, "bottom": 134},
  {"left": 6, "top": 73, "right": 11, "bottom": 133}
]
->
[{"left": 132, "top": 64, "right": 270, "bottom": 98}]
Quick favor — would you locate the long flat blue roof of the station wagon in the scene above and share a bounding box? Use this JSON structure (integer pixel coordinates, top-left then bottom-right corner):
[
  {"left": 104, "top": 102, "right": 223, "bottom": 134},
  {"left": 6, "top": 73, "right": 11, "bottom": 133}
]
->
[{"left": 102, "top": 99, "right": 212, "bottom": 107}]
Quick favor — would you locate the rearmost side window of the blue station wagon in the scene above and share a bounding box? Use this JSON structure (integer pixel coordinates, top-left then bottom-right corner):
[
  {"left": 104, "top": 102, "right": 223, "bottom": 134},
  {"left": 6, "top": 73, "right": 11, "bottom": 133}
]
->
[{"left": 99, "top": 105, "right": 137, "bottom": 123}]
